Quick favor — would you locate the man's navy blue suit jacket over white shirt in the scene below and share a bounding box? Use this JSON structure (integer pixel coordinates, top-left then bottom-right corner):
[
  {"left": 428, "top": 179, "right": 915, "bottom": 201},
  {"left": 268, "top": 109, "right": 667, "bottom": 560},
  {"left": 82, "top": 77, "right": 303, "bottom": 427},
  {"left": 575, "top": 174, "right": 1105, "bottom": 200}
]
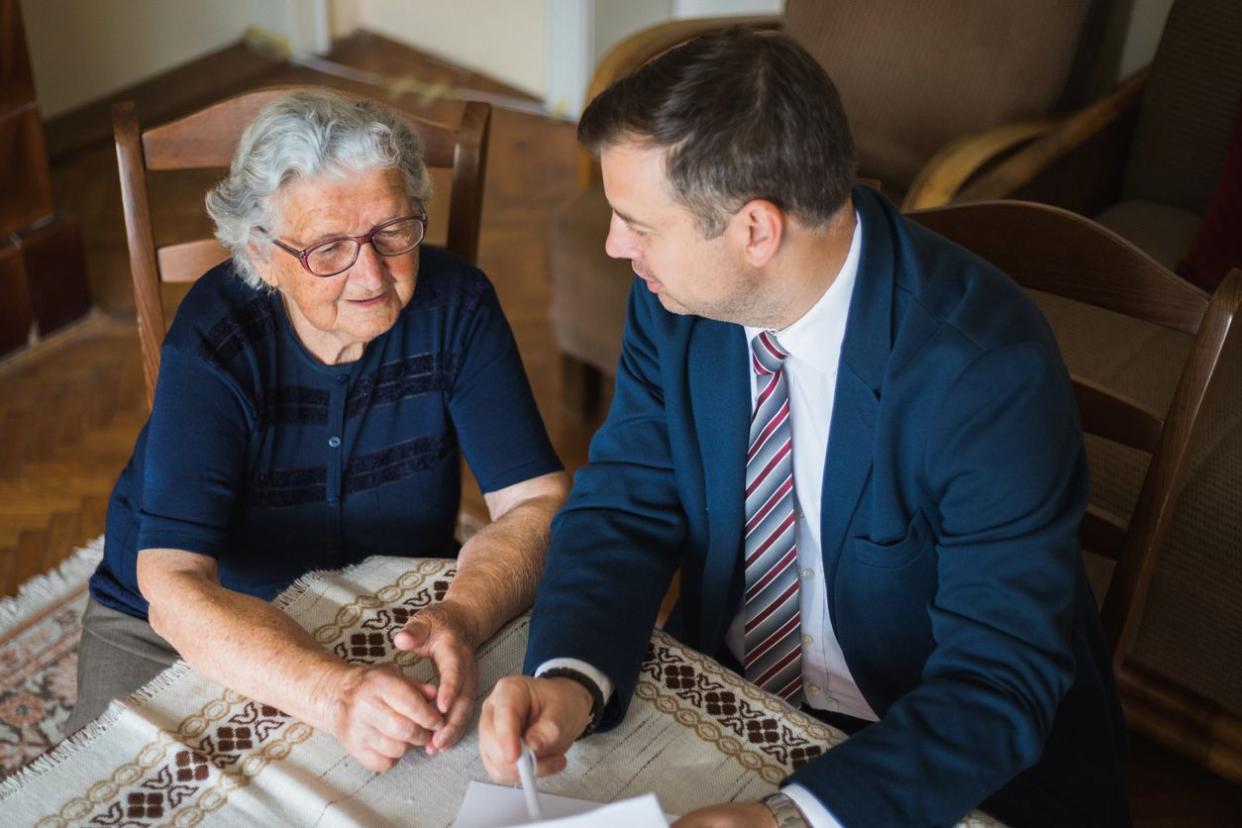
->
[{"left": 527, "top": 189, "right": 1128, "bottom": 826}]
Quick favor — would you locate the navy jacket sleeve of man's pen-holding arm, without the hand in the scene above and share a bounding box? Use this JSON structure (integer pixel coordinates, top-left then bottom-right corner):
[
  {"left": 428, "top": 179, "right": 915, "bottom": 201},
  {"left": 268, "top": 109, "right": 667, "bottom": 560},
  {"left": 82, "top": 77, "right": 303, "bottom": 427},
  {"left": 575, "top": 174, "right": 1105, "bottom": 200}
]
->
[{"left": 523, "top": 279, "right": 686, "bottom": 729}]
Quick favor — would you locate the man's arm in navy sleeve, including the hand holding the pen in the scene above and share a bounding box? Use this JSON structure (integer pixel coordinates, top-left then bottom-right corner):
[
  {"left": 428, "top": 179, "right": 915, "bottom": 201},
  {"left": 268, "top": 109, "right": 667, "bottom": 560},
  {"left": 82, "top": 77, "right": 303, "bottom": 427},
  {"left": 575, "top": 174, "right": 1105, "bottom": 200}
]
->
[{"left": 479, "top": 281, "right": 686, "bottom": 781}]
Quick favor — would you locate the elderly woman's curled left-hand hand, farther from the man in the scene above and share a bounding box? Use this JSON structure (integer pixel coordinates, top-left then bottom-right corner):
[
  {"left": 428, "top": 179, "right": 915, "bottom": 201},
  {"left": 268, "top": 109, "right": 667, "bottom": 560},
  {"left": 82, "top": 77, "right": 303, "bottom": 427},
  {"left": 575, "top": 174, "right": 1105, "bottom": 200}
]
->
[{"left": 315, "top": 664, "right": 445, "bottom": 773}]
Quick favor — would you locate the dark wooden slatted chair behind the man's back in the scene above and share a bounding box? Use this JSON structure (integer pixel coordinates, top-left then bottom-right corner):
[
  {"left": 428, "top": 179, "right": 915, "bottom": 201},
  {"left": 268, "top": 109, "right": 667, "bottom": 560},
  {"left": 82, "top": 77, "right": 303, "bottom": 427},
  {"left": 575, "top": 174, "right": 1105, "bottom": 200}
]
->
[{"left": 909, "top": 201, "right": 1242, "bottom": 780}]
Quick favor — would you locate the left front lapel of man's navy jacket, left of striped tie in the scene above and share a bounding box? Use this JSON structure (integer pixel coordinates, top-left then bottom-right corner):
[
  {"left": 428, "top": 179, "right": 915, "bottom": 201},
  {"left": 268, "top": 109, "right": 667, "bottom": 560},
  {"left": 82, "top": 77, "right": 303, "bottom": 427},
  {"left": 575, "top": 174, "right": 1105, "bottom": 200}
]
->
[{"left": 689, "top": 319, "right": 750, "bottom": 648}]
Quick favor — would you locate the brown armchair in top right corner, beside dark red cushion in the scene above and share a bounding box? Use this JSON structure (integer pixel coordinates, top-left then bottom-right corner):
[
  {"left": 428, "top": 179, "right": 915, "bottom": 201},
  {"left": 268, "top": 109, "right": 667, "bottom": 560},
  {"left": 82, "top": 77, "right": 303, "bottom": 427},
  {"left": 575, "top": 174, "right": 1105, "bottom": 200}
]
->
[{"left": 938, "top": 0, "right": 1242, "bottom": 268}]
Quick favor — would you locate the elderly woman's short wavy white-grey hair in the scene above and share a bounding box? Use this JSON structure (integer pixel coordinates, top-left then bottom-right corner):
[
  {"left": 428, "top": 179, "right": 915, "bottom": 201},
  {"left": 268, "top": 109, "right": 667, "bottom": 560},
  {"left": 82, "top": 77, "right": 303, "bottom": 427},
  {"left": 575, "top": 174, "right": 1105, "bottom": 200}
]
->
[{"left": 206, "top": 89, "right": 431, "bottom": 288}]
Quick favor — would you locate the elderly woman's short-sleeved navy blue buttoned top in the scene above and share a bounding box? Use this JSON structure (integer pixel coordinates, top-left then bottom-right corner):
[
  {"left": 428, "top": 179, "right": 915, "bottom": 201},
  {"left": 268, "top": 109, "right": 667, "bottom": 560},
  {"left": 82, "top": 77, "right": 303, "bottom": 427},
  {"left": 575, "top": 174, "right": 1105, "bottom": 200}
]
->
[{"left": 91, "top": 248, "right": 560, "bottom": 617}]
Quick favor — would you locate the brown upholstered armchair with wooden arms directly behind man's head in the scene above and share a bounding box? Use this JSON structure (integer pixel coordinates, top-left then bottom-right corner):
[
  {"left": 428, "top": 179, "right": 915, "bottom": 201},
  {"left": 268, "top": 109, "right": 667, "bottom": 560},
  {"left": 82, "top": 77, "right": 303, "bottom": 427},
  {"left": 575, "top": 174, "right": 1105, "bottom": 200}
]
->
[{"left": 549, "top": 0, "right": 1113, "bottom": 412}]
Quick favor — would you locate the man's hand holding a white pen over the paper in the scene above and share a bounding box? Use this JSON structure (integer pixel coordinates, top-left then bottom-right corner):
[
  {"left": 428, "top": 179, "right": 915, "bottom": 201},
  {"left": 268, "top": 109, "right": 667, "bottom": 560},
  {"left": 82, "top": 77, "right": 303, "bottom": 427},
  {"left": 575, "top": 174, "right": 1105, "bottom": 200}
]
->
[{"left": 478, "top": 675, "right": 592, "bottom": 785}]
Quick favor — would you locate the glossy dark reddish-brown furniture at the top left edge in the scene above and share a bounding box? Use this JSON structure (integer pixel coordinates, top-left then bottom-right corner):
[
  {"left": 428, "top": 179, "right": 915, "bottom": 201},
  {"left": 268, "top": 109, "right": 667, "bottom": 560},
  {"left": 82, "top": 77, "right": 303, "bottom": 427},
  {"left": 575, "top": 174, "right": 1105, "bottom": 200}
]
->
[{"left": 0, "top": 0, "right": 91, "bottom": 354}]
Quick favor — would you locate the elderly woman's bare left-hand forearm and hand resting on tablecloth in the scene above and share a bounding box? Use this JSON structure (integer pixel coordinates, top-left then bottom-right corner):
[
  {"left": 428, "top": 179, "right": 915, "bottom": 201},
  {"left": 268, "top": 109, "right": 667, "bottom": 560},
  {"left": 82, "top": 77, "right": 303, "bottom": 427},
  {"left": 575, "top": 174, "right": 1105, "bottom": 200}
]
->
[{"left": 138, "top": 549, "right": 443, "bottom": 771}]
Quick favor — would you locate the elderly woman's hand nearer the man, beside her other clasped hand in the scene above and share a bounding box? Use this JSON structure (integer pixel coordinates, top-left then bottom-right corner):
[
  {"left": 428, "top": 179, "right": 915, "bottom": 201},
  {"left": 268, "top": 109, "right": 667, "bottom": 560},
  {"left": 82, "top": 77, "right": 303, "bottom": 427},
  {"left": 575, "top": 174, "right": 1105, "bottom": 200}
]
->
[{"left": 392, "top": 601, "right": 479, "bottom": 756}]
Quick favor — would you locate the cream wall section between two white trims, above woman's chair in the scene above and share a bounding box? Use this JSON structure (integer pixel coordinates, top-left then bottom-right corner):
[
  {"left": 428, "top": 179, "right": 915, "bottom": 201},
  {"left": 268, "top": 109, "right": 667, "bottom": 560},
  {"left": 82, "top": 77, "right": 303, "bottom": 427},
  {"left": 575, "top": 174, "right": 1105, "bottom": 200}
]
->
[{"left": 333, "top": 0, "right": 548, "bottom": 99}]
